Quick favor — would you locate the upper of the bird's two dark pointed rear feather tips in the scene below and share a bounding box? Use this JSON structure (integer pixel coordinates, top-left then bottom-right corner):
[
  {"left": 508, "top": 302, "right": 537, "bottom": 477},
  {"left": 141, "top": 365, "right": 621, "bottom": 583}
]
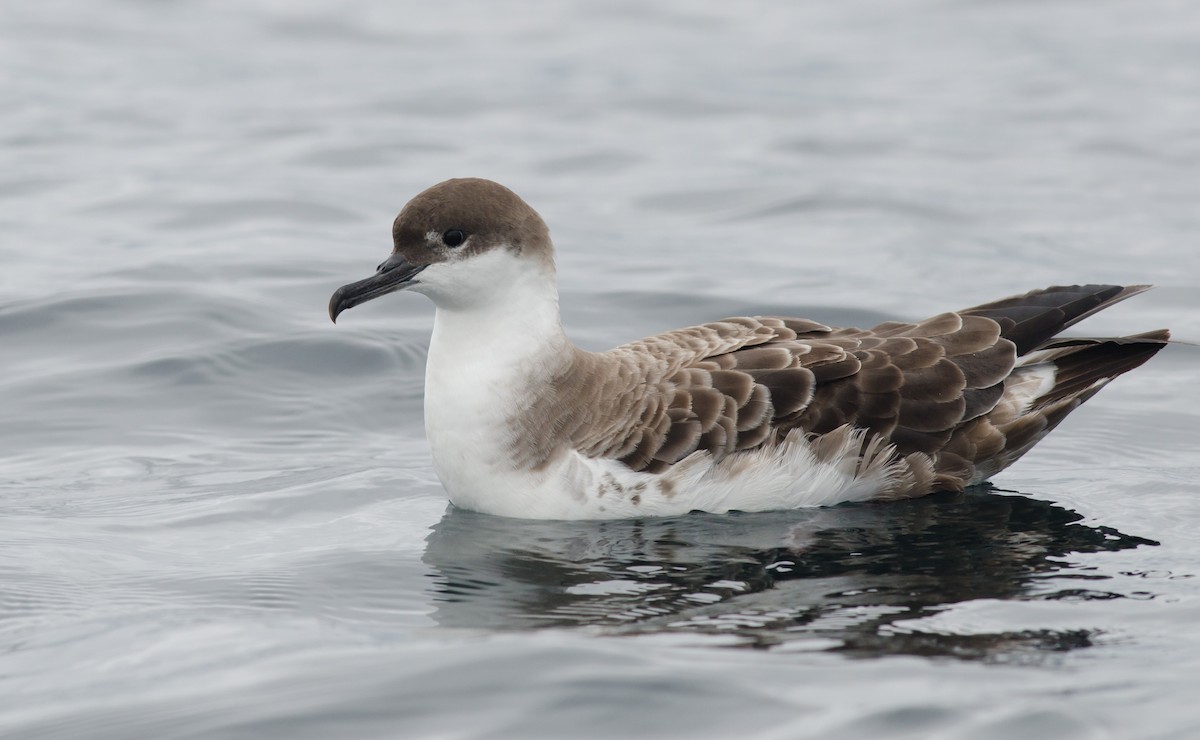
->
[{"left": 959, "top": 285, "right": 1157, "bottom": 355}]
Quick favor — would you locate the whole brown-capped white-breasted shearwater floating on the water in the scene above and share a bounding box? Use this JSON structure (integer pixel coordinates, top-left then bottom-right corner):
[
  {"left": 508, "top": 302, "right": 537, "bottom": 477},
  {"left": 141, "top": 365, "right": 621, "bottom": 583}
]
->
[{"left": 329, "top": 179, "right": 1169, "bottom": 519}]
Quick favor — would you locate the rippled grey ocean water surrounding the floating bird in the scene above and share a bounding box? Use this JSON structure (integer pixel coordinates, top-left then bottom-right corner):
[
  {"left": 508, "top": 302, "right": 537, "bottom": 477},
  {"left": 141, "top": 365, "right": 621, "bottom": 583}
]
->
[{"left": 0, "top": 0, "right": 1200, "bottom": 739}]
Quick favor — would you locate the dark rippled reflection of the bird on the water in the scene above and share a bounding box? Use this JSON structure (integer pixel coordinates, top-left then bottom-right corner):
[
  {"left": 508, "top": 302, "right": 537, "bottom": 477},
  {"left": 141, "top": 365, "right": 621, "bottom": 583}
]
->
[{"left": 424, "top": 489, "right": 1157, "bottom": 660}]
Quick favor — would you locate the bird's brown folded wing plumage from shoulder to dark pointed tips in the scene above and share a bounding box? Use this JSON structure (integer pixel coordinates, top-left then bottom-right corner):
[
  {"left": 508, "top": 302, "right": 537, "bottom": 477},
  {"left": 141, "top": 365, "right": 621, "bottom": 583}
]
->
[{"left": 540, "top": 285, "right": 1165, "bottom": 497}]
